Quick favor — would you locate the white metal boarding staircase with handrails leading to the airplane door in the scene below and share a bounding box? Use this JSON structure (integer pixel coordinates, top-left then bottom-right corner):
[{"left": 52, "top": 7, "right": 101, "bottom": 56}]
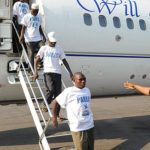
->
[{"left": 12, "top": 22, "right": 70, "bottom": 150}]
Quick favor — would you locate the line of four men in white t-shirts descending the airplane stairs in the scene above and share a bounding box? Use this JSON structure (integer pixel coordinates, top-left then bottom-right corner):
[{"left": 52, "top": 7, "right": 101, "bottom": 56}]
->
[{"left": 13, "top": 0, "right": 94, "bottom": 150}]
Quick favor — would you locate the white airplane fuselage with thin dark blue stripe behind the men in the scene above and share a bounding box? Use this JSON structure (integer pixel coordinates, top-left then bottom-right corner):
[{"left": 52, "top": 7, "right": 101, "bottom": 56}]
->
[{"left": 0, "top": 0, "right": 150, "bottom": 100}]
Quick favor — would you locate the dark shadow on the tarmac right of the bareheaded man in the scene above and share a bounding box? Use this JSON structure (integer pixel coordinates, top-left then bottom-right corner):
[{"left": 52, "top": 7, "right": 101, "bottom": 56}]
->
[{"left": 95, "top": 116, "right": 150, "bottom": 150}]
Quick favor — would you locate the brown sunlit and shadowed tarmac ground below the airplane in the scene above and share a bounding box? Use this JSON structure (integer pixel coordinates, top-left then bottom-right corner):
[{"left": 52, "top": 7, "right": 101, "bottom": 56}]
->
[{"left": 0, "top": 95, "right": 150, "bottom": 150}]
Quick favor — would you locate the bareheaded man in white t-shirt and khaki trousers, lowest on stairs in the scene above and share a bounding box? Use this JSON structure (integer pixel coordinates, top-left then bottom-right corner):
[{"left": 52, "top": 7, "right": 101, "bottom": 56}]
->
[{"left": 53, "top": 72, "right": 94, "bottom": 150}]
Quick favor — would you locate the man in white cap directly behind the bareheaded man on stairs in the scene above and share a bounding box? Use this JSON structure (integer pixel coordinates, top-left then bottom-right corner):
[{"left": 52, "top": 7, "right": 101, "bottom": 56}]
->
[{"left": 33, "top": 32, "right": 73, "bottom": 119}]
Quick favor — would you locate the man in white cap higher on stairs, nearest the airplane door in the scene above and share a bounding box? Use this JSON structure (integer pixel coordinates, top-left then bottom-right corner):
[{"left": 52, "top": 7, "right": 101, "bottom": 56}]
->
[{"left": 19, "top": 3, "right": 46, "bottom": 72}]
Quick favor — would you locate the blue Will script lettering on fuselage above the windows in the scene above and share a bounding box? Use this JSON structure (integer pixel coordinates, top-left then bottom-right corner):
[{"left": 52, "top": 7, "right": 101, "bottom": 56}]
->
[{"left": 77, "top": 0, "right": 140, "bottom": 17}]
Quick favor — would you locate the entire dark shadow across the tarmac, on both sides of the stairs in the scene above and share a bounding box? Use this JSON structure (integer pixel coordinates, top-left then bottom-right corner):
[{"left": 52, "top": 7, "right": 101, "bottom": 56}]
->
[{"left": 0, "top": 116, "right": 150, "bottom": 150}]
